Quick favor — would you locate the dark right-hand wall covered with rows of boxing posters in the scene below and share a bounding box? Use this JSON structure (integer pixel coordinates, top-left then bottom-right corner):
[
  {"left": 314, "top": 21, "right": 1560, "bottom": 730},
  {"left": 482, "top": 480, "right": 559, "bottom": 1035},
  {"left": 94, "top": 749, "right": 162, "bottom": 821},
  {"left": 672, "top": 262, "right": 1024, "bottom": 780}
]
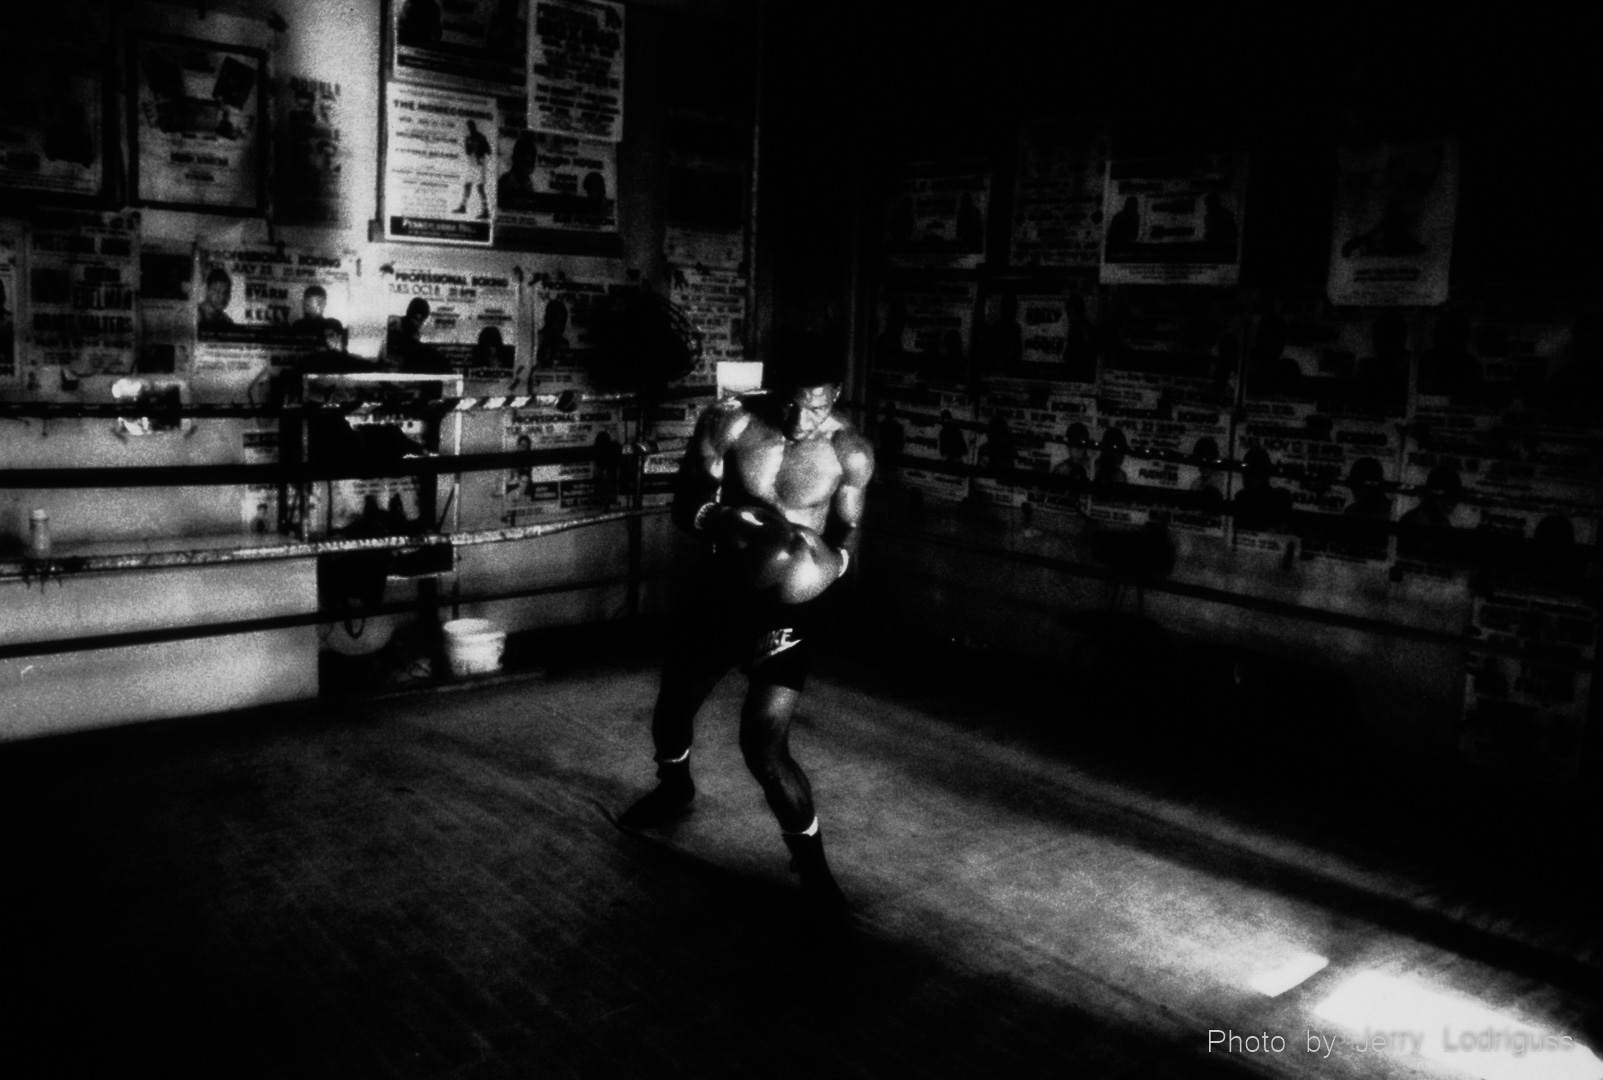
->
[{"left": 827, "top": 3, "right": 1603, "bottom": 780}]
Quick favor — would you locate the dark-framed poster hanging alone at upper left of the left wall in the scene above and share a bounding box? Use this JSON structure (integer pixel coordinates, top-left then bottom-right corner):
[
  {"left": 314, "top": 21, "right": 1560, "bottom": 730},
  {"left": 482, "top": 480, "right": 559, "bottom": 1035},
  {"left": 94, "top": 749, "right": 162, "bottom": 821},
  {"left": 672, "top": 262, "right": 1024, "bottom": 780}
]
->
[{"left": 128, "top": 35, "right": 268, "bottom": 213}]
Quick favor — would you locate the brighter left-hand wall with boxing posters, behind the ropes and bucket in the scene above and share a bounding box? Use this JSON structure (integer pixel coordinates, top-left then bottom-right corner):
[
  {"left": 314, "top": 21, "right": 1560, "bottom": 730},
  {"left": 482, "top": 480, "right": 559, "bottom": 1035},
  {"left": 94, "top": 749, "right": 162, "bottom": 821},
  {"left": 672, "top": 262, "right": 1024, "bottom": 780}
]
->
[{"left": 0, "top": 0, "right": 753, "bottom": 739}]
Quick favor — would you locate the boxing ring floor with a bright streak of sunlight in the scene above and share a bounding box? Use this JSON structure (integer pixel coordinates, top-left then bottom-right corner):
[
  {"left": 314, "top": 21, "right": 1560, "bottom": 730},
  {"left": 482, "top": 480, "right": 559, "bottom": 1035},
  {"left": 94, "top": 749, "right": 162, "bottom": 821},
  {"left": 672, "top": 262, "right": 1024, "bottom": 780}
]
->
[{"left": 0, "top": 621, "right": 1603, "bottom": 1080}]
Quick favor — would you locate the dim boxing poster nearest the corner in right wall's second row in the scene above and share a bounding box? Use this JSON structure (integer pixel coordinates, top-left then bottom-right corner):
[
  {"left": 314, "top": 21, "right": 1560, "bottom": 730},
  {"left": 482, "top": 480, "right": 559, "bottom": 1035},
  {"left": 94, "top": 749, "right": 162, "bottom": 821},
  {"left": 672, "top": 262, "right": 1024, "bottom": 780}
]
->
[{"left": 872, "top": 276, "right": 979, "bottom": 385}]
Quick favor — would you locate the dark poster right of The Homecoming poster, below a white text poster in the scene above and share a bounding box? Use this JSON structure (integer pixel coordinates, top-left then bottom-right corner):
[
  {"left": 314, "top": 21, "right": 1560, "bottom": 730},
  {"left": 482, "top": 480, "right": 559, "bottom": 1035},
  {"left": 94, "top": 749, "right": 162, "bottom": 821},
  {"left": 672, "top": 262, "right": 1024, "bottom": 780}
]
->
[{"left": 495, "top": 101, "right": 617, "bottom": 235}]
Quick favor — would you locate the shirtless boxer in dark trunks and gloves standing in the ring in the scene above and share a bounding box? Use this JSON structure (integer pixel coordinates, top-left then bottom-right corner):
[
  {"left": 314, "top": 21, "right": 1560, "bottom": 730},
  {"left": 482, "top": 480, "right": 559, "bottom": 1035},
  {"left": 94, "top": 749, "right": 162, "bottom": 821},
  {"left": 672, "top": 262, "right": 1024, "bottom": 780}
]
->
[{"left": 619, "top": 336, "right": 874, "bottom": 913}]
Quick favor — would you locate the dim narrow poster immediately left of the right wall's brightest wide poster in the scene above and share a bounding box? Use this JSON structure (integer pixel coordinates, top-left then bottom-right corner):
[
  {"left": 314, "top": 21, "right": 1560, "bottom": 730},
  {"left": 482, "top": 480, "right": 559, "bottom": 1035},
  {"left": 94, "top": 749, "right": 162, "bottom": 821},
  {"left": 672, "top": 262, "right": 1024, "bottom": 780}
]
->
[{"left": 1010, "top": 120, "right": 1108, "bottom": 269}]
